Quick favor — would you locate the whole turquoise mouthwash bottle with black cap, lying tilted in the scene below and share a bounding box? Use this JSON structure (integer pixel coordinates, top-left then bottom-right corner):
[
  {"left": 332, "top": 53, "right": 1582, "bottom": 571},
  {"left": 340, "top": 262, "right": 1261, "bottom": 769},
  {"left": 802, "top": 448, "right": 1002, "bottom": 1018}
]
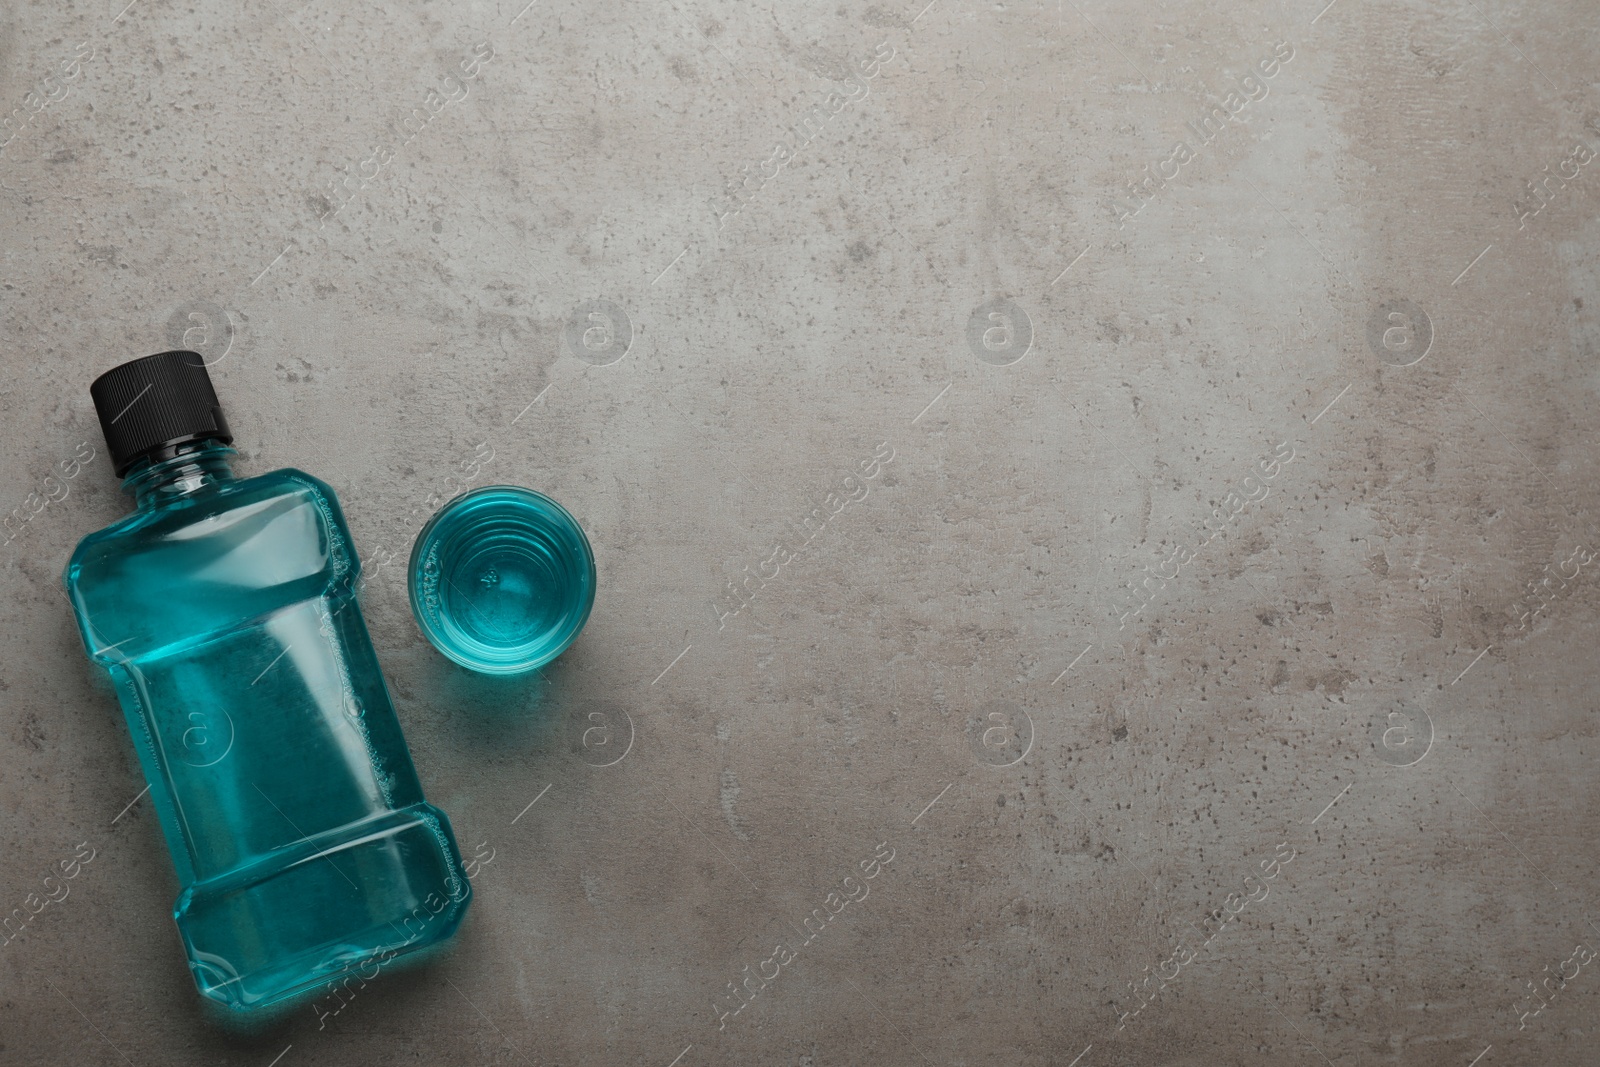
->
[{"left": 62, "top": 352, "right": 472, "bottom": 1013}]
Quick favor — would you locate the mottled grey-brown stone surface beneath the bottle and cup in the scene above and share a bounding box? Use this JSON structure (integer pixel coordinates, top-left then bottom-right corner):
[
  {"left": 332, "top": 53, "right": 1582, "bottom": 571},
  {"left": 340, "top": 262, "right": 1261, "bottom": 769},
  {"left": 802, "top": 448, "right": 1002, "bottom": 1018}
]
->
[{"left": 0, "top": 0, "right": 1600, "bottom": 1067}]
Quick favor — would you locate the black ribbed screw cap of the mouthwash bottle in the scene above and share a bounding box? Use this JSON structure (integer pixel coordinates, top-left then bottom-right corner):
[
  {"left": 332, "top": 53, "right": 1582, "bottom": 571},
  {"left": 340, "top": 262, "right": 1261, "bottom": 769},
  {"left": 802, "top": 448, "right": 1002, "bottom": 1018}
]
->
[{"left": 90, "top": 350, "right": 234, "bottom": 478}]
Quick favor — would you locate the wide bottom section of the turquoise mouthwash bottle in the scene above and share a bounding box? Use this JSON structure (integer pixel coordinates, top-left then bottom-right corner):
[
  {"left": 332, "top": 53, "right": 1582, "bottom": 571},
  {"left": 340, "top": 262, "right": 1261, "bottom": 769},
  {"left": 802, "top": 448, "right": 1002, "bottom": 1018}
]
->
[{"left": 173, "top": 803, "right": 472, "bottom": 1013}]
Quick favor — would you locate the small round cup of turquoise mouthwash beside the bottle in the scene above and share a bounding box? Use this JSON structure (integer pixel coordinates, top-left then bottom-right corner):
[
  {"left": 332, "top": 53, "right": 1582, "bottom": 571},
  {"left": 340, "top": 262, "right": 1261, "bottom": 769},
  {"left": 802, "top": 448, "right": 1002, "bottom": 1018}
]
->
[{"left": 408, "top": 485, "right": 595, "bottom": 675}]
